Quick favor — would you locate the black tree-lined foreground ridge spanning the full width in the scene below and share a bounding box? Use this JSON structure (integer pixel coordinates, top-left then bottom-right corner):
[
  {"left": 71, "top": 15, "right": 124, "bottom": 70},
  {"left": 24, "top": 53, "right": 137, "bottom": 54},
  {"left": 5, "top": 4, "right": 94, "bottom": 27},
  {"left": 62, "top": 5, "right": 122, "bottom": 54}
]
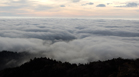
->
[{"left": 0, "top": 52, "right": 139, "bottom": 77}]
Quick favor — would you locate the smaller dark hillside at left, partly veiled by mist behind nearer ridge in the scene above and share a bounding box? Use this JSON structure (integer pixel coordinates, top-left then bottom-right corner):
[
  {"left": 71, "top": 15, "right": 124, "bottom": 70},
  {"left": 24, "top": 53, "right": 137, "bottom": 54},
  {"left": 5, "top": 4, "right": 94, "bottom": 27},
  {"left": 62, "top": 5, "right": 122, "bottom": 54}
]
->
[{"left": 0, "top": 50, "right": 35, "bottom": 70}]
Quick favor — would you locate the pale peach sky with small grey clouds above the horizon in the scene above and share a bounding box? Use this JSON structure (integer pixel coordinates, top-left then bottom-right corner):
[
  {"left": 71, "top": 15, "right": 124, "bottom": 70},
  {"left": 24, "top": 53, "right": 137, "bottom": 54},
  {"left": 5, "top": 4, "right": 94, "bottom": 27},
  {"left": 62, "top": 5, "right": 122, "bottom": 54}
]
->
[{"left": 0, "top": 0, "right": 139, "bottom": 18}]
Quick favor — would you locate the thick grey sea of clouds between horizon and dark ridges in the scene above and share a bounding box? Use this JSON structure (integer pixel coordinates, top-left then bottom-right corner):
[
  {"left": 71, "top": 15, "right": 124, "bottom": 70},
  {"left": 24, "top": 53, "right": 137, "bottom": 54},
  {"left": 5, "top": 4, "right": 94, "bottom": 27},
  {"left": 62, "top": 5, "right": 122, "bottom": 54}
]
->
[{"left": 0, "top": 18, "right": 139, "bottom": 63}]
